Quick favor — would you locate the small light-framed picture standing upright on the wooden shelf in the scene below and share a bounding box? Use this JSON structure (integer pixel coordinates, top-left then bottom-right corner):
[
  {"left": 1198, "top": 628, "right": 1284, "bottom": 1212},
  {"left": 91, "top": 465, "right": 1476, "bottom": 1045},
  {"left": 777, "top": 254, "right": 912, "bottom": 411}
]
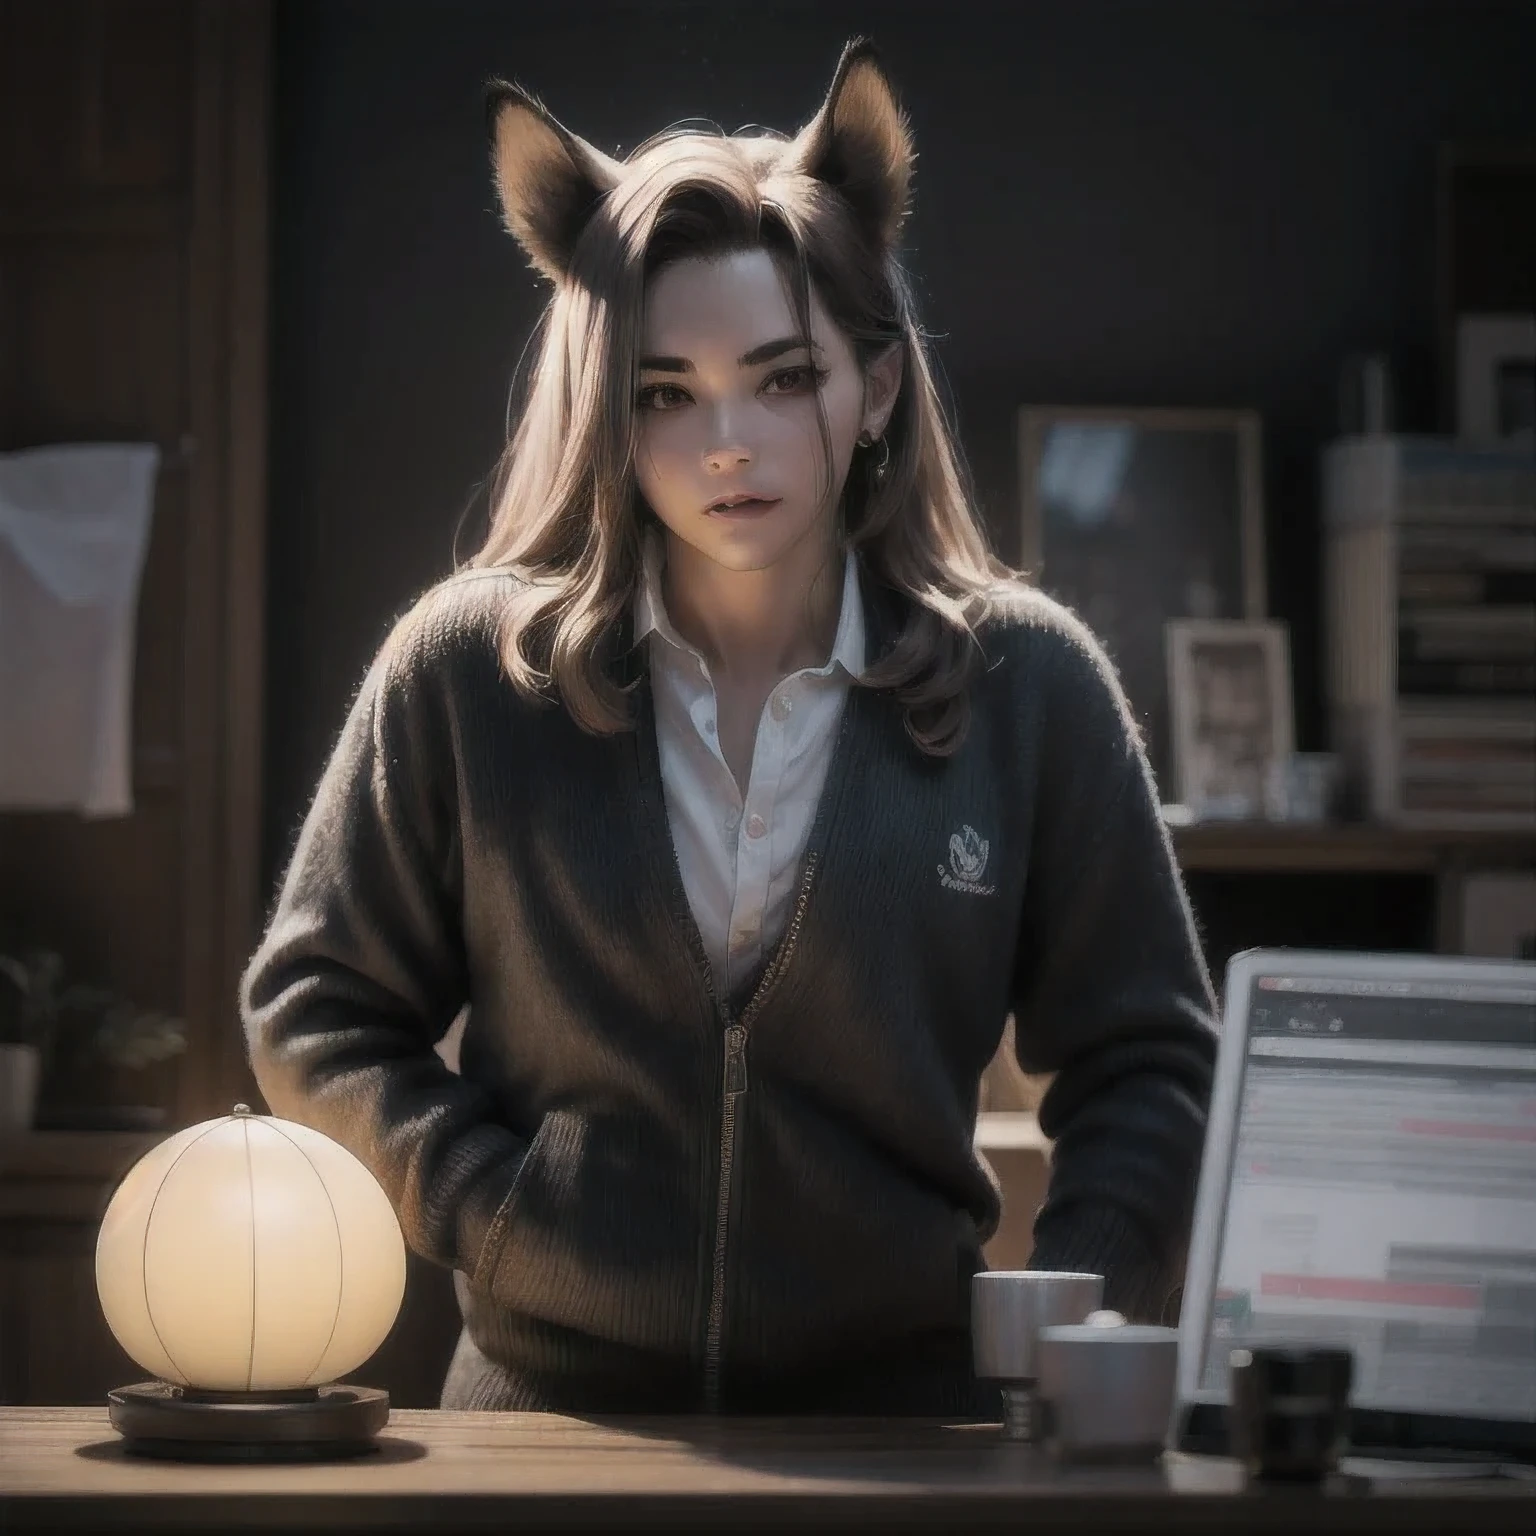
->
[{"left": 1167, "top": 619, "right": 1295, "bottom": 820}]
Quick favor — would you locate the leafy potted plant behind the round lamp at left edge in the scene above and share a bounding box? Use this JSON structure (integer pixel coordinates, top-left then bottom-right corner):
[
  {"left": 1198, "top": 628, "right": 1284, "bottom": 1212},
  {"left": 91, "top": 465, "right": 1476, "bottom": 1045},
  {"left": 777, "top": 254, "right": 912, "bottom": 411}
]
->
[{"left": 0, "top": 949, "right": 186, "bottom": 1134}]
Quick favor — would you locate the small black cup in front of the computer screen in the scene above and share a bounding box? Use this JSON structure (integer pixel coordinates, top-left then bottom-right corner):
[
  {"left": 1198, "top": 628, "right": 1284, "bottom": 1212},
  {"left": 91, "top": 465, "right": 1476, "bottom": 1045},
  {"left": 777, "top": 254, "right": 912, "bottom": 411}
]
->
[{"left": 1227, "top": 1347, "right": 1355, "bottom": 1482}]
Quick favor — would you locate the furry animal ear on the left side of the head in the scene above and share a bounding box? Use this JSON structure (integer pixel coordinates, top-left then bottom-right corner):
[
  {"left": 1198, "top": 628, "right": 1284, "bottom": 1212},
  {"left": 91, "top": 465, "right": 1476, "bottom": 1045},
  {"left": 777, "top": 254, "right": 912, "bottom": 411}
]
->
[{"left": 485, "top": 80, "right": 624, "bottom": 280}]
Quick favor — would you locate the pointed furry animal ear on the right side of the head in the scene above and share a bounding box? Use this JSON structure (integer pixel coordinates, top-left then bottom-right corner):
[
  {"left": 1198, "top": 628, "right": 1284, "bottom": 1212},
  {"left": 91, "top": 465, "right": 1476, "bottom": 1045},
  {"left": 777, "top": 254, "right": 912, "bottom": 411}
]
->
[{"left": 785, "top": 38, "right": 914, "bottom": 244}]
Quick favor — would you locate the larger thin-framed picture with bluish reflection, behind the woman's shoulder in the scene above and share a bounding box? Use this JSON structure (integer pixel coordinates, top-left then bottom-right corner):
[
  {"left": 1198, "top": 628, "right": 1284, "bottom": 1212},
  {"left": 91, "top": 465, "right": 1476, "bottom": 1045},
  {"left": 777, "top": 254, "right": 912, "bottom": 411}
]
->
[{"left": 1018, "top": 406, "right": 1266, "bottom": 780}]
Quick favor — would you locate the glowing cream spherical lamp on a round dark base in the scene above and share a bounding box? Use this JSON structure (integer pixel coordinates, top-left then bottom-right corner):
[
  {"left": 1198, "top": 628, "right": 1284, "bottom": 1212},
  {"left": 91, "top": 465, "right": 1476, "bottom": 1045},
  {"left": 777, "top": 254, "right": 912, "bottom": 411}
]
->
[{"left": 95, "top": 1104, "right": 406, "bottom": 1459}]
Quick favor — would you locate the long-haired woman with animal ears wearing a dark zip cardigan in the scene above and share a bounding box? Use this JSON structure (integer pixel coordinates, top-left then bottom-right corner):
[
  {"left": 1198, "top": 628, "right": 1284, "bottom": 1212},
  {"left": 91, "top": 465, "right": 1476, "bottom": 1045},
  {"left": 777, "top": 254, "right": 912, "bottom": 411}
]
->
[{"left": 243, "top": 43, "right": 1215, "bottom": 1418}]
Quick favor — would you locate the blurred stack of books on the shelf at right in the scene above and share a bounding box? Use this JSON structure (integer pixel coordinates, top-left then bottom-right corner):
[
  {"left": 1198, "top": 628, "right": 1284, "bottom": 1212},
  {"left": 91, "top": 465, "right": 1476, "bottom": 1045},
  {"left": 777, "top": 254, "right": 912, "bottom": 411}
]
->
[{"left": 1322, "top": 436, "right": 1536, "bottom": 829}]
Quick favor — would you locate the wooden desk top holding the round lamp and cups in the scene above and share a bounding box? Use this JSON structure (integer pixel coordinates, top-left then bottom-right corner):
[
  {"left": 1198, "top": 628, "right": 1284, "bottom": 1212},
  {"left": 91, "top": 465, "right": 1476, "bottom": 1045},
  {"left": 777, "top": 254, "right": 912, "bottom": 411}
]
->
[{"left": 0, "top": 1407, "right": 1536, "bottom": 1536}]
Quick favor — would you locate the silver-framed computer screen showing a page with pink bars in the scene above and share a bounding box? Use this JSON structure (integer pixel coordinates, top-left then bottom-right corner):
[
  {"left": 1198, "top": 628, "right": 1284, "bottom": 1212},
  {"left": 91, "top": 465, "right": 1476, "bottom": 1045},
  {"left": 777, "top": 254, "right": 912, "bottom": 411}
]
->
[{"left": 1169, "top": 949, "right": 1536, "bottom": 1461}]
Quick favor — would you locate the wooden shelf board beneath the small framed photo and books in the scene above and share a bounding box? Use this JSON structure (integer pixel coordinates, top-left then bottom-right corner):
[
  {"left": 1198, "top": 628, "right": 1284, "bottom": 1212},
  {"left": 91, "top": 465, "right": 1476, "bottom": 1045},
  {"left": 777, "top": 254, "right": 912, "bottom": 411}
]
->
[{"left": 1172, "top": 822, "right": 1536, "bottom": 876}]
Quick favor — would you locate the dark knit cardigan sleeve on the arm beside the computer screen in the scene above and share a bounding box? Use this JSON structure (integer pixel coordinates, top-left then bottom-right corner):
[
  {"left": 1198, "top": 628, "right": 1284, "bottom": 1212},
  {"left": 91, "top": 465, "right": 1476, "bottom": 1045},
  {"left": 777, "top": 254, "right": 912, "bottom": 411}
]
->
[{"left": 1014, "top": 617, "right": 1217, "bottom": 1321}]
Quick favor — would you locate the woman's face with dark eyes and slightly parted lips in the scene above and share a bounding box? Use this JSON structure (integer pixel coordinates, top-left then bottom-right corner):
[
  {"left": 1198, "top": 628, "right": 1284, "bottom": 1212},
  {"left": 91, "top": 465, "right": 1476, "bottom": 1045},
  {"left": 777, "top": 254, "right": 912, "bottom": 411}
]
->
[{"left": 634, "top": 250, "right": 894, "bottom": 571}]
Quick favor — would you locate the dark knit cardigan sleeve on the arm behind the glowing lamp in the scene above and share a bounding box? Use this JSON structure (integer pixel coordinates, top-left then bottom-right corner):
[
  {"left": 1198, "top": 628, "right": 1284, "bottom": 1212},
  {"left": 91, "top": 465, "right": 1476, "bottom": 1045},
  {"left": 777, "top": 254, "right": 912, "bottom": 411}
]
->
[{"left": 241, "top": 599, "right": 527, "bottom": 1275}]
